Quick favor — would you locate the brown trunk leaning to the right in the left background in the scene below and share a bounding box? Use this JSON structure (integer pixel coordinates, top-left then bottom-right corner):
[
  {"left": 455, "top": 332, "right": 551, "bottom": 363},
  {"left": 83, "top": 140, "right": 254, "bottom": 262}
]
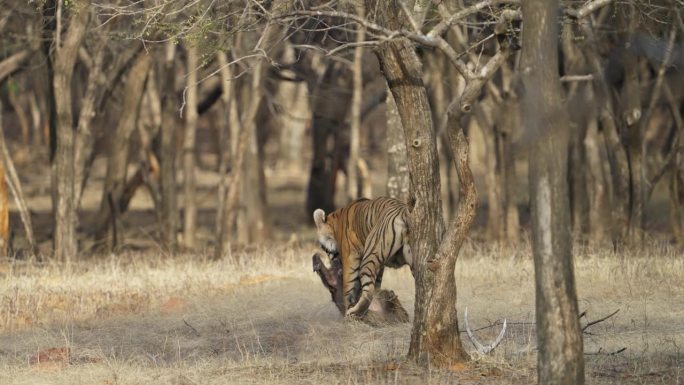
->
[{"left": 95, "top": 55, "right": 151, "bottom": 250}]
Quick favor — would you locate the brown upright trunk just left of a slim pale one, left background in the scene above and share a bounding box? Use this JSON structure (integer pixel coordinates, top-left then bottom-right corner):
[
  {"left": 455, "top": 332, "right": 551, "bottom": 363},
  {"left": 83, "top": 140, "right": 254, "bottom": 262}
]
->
[{"left": 159, "top": 41, "right": 178, "bottom": 252}]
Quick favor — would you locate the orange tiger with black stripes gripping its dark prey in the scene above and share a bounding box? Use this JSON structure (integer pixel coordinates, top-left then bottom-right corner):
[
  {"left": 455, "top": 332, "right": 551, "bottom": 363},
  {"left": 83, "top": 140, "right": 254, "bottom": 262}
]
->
[{"left": 313, "top": 197, "right": 412, "bottom": 317}]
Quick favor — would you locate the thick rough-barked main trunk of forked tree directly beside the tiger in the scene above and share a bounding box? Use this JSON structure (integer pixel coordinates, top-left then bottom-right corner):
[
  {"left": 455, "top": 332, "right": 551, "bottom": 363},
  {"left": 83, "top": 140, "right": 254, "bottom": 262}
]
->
[{"left": 378, "top": 36, "right": 467, "bottom": 366}]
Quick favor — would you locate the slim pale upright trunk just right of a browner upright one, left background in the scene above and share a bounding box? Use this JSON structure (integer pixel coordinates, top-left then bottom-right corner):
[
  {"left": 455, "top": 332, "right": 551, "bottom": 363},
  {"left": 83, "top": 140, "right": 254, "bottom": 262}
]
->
[{"left": 183, "top": 46, "right": 199, "bottom": 249}]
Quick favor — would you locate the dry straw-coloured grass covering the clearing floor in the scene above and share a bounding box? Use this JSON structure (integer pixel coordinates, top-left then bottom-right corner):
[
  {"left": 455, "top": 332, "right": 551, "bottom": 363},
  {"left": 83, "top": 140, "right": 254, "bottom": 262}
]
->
[{"left": 0, "top": 244, "right": 684, "bottom": 384}]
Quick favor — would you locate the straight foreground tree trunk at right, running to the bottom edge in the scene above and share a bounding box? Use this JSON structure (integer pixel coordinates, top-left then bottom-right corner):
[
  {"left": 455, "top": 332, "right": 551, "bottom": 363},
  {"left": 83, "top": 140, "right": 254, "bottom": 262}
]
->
[{"left": 521, "top": 0, "right": 584, "bottom": 385}]
